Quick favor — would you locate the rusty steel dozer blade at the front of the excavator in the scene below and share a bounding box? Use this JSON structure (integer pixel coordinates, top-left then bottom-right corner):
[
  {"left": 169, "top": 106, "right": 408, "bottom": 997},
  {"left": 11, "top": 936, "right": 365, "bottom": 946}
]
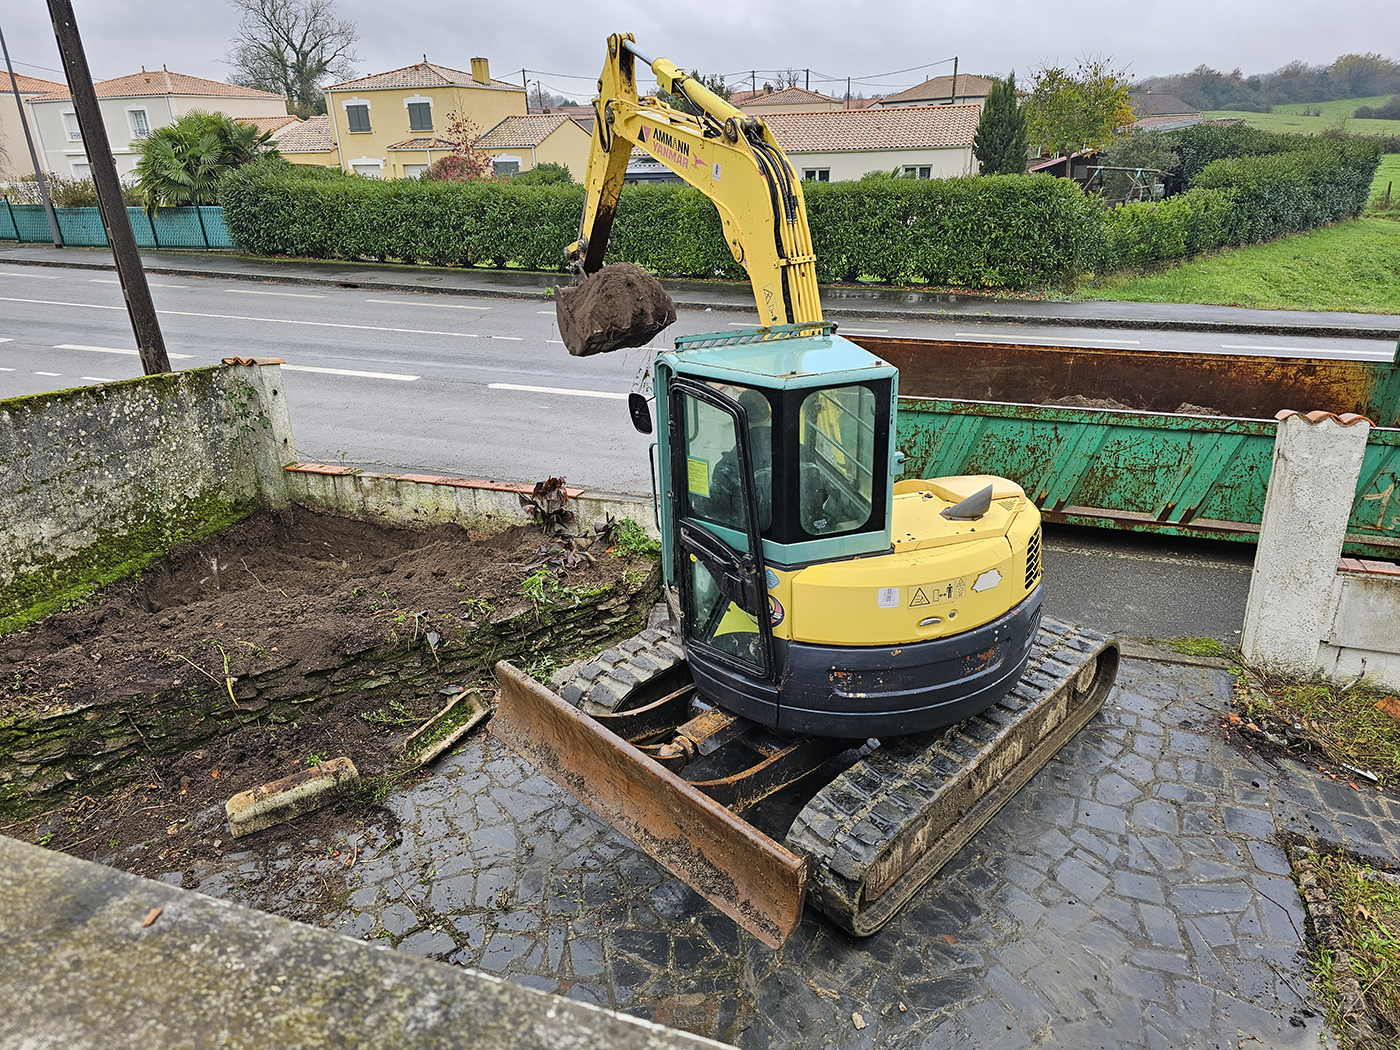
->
[{"left": 491, "top": 661, "right": 808, "bottom": 948}]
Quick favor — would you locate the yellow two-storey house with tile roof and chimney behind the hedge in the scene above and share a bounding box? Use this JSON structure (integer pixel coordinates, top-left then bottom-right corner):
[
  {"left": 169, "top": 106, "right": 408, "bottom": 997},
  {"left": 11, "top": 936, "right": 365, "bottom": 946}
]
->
[{"left": 320, "top": 56, "right": 526, "bottom": 179}]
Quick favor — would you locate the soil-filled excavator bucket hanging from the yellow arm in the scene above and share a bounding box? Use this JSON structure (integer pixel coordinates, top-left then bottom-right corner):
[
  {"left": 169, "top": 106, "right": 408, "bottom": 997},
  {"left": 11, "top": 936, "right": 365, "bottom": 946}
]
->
[{"left": 554, "top": 263, "right": 676, "bottom": 357}]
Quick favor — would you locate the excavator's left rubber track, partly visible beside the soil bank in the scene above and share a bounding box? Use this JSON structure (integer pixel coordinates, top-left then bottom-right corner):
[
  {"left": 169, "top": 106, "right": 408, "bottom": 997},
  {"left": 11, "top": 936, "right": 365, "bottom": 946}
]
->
[{"left": 549, "top": 626, "right": 689, "bottom": 714}]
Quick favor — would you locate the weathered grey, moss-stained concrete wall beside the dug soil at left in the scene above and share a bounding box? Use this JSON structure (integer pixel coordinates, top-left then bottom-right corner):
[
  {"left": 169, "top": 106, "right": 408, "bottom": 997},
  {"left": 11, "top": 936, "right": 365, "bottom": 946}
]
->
[{"left": 0, "top": 364, "right": 297, "bottom": 627}]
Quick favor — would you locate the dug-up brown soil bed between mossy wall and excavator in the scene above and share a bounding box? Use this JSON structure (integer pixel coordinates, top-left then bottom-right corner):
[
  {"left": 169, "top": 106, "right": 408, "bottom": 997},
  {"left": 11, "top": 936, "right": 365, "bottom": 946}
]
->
[{"left": 0, "top": 508, "right": 652, "bottom": 890}]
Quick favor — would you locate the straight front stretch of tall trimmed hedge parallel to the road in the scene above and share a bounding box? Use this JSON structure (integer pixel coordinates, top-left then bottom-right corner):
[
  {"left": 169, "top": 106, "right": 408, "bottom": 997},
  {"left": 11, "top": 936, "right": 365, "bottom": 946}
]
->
[{"left": 223, "top": 169, "right": 1099, "bottom": 288}]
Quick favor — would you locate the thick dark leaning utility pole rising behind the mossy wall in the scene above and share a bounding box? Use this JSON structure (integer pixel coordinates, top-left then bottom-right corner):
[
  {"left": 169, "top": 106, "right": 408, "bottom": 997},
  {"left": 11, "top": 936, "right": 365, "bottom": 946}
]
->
[{"left": 49, "top": 0, "right": 171, "bottom": 375}]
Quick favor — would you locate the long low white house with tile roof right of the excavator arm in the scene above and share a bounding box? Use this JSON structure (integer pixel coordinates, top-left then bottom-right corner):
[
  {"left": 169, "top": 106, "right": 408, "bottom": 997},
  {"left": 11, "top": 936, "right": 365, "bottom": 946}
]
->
[{"left": 763, "top": 104, "right": 981, "bottom": 182}]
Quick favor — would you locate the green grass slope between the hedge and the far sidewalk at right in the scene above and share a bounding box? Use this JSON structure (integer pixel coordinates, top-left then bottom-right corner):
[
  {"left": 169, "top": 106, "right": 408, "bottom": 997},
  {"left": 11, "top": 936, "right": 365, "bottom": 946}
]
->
[{"left": 1079, "top": 215, "right": 1400, "bottom": 314}]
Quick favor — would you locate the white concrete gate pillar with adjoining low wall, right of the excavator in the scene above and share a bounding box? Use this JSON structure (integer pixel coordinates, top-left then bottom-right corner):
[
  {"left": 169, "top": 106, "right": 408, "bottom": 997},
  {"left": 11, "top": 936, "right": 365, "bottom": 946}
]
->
[{"left": 1240, "top": 412, "right": 1400, "bottom": 700}]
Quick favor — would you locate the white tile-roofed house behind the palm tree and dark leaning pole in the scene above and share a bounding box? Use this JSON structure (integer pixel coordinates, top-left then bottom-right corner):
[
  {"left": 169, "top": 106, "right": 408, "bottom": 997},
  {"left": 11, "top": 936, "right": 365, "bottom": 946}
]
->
[{"left": 27, "top": 69, "right": 287, "bottom": 175}]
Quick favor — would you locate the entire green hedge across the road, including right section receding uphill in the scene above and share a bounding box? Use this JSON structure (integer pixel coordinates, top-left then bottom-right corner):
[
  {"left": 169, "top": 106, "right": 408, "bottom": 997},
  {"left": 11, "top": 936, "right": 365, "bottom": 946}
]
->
[{"left": 221, "top": 125, "right": 1380, "bottom": 288}]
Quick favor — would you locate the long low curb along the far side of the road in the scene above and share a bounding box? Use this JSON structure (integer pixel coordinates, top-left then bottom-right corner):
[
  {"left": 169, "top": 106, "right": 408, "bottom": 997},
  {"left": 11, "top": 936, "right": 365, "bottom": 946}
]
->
[{"left": 0, "top": 252, "right": 1400, "bottom": 340}]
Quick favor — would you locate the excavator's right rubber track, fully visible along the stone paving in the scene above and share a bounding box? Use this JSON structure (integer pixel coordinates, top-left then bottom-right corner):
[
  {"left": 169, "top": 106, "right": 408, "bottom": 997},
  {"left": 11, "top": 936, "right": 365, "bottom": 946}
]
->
[{"left": 787, "top": 617, "right": 1117, "bottom": 935}]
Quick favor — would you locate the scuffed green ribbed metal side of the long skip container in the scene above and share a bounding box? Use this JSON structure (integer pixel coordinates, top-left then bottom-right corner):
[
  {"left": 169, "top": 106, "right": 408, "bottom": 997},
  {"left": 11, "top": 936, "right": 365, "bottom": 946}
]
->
[{"left": 897, "top": 398, "right": 1400, "bottom": 557}]
